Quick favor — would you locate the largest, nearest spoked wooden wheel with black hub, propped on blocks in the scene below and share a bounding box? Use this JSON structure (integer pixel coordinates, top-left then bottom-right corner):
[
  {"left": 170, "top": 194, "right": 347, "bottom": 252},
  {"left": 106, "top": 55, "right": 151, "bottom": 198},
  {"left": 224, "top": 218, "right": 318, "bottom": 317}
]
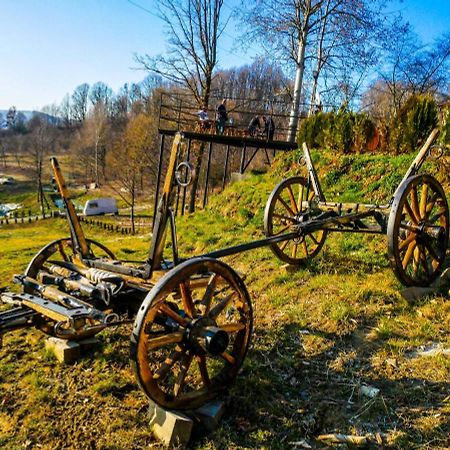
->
[{"left": 131, "top": 258, "right": 252, "bottom": 409}]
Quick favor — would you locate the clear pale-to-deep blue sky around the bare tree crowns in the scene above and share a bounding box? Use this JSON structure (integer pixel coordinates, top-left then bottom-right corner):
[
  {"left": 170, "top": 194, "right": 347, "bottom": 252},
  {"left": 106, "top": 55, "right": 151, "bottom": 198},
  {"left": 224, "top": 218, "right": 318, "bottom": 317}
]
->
[{"left": 0, "top": 0, "right": 450, "bottom": 109}]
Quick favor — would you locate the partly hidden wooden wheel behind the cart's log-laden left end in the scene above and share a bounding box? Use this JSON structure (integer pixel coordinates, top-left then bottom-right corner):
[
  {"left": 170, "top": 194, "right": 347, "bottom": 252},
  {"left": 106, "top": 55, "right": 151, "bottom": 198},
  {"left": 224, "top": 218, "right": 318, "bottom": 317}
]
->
[{"left": 25, "top": 238, "right": 116, "bottom": 278}]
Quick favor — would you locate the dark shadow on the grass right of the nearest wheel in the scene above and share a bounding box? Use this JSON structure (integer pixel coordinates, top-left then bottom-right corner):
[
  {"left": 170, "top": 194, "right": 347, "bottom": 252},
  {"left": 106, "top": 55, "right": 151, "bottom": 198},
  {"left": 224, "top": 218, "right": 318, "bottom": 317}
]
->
[{"left": 209, "top": 318, "right": 450, "bottom": 449}]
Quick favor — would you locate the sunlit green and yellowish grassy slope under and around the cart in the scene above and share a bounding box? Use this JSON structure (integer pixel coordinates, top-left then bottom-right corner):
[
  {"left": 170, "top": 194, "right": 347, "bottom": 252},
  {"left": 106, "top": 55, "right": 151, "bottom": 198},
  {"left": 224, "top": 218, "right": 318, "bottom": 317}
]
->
[{"left": 0, "top": 146, "right": 450, "bottom": 449}]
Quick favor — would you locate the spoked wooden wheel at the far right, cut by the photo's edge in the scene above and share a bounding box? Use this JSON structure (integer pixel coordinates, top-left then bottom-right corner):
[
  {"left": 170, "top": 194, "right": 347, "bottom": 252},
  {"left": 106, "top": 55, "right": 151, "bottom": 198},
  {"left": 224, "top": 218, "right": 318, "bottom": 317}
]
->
[{"left": 388, "top": 174, "right": 449, "bottom": 286}]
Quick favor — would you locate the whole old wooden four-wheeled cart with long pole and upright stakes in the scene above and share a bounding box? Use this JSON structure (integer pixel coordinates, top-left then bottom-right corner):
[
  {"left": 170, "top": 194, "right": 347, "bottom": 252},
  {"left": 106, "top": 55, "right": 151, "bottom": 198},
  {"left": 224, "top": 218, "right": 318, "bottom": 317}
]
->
[{"left": 0, "top": 130, "right": 449, "bottom": 409}]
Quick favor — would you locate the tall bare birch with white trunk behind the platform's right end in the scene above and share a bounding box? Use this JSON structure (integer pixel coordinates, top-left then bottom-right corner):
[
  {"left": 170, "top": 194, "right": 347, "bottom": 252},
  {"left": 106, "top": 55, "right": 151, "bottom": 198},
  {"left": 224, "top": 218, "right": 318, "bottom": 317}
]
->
[{"left": 243, "top": 0, "right": 386, "bottom": 141}]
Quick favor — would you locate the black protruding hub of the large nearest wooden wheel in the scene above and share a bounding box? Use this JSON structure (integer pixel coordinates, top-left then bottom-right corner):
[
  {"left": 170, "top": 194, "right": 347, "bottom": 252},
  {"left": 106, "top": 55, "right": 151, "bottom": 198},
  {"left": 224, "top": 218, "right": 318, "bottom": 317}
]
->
[{"left": 185, "top": 317, "right": 230, "bottom": 356}]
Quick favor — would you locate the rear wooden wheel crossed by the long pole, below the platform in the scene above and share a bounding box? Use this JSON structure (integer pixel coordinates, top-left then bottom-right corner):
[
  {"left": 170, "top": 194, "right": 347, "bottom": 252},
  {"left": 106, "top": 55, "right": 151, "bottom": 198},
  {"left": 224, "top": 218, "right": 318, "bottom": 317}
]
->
[{"left": 264, "top": 177, "right": 327, "bottom": 265}]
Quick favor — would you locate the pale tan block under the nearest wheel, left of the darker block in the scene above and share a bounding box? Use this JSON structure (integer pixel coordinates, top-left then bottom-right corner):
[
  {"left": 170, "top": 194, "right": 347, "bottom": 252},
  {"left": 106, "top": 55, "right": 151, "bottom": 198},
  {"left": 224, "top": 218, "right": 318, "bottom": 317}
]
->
[{"left": 149, "top": 402, "right": 194, "bottom": 448}]
